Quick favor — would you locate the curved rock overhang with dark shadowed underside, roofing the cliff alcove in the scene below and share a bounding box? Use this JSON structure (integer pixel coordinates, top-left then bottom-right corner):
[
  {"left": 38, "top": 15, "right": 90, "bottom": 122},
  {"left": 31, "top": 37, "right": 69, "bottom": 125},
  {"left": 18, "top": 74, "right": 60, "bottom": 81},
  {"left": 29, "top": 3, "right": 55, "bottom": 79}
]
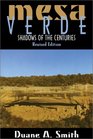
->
[{"left": 5, "top": 97, "right": 80, "bottom": 107}]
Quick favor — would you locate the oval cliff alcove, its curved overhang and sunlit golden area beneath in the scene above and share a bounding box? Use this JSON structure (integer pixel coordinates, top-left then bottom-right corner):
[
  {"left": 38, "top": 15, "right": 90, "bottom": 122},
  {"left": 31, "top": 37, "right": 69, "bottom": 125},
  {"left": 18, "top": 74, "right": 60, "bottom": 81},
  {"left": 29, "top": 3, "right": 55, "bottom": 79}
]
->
[{"left": 5, "top": 97, "right": 79, "bottom": 121}]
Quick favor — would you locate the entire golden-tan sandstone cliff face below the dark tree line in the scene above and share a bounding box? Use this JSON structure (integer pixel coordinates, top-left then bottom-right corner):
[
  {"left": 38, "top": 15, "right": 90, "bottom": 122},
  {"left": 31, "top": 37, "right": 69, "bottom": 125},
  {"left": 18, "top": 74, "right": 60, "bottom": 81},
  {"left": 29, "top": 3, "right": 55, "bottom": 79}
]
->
[{"left": 0, "top": 85, "right": 92, "bottom": 127}]
